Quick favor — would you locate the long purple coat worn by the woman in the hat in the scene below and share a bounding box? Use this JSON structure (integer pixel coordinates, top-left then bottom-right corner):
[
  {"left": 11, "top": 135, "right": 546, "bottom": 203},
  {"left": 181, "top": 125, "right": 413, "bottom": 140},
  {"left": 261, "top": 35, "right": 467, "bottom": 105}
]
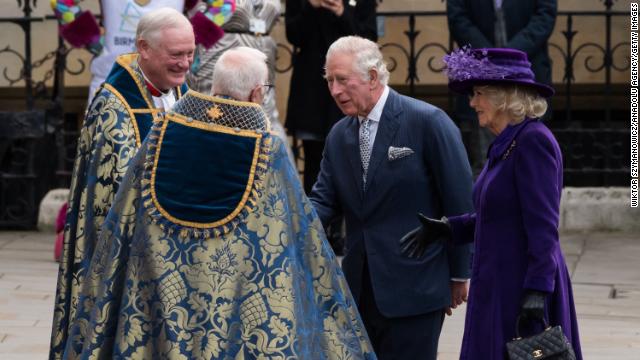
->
[{"left": 449, "top": 119, "right": 582, "bottom": 359}]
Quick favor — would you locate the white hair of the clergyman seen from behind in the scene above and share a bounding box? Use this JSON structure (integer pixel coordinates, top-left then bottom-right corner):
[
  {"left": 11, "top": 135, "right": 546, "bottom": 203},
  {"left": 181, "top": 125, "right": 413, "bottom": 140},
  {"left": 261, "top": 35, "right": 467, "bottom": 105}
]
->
[{"left": 211, "top": 46, "right": 269, "bottom": 100}]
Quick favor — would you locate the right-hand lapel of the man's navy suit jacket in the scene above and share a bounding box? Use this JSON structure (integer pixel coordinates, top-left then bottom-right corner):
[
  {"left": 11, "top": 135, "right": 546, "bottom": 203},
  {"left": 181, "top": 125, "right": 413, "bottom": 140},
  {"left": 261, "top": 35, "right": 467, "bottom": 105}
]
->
[{"left": 366, "top": 89, "right": 402, "bottom": 191}]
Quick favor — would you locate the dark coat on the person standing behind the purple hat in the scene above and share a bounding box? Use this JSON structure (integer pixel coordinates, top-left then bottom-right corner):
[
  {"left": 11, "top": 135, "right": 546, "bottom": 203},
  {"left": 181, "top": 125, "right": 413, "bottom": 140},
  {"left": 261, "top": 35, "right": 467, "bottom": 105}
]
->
[{"left": 447, "top": 0, "right": 558, "bottom": 84}]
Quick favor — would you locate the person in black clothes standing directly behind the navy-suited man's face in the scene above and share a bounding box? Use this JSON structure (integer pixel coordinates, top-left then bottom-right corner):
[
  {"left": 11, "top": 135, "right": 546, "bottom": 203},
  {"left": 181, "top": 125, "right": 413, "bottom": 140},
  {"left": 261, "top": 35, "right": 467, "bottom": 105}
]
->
[{"left": 285, "top": 0, "right": 378, "bottom": 255}]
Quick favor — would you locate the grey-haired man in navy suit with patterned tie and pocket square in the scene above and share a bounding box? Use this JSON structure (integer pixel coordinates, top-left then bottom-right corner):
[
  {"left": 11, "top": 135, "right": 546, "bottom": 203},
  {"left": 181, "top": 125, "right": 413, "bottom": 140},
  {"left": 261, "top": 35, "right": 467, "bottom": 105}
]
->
[{"left": 309, "top": 36, "right": 472, "bottom": 360}]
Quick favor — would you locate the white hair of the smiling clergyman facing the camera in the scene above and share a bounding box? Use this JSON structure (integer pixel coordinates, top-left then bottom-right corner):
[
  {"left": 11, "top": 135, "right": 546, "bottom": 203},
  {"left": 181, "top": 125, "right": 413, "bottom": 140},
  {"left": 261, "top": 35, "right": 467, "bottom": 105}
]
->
[{"left": 136, "top": 7, "right": 193, "bottom": 47}]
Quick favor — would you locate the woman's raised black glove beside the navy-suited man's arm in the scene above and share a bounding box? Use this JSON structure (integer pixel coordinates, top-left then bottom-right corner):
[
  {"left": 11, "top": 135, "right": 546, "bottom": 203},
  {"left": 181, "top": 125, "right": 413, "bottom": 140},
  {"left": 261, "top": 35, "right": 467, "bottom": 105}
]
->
[{"left": 400, "top": 213, "right": 451, "bottom": 258}]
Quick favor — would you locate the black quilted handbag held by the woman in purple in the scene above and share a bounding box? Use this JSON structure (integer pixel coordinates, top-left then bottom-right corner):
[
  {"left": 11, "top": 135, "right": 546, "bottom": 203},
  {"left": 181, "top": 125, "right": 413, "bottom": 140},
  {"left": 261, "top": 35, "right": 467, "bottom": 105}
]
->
[{"left": 507, "top": 316, "right": 576, "bottom": 360}]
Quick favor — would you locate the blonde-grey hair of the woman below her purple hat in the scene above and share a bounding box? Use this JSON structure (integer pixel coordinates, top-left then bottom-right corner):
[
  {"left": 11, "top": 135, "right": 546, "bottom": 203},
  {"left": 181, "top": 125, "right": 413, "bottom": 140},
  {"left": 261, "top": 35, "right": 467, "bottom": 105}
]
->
[{"left": 479, "top": 85, "right": 548, "bottom": 124}]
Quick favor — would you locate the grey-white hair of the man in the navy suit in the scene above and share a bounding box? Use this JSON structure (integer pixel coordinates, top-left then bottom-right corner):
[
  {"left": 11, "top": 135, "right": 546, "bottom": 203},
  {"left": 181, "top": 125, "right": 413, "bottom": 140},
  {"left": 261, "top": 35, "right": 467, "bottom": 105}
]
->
[{"left": 325, "top": 36, "right": 389, "bottom": 85}]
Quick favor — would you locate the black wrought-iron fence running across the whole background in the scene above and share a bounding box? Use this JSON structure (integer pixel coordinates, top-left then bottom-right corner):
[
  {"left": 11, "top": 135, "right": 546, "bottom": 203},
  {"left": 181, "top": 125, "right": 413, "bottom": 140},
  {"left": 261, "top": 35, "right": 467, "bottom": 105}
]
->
[{"left": 0, "top": 0, "right": 630, "bottom": 228}]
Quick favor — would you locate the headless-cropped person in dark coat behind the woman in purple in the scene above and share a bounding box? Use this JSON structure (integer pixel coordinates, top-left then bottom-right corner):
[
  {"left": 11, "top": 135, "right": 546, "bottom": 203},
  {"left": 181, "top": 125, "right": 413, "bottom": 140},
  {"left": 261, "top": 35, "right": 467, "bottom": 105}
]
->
[{"left": 447, "top": 0, "right": 558, "bottom": 175}]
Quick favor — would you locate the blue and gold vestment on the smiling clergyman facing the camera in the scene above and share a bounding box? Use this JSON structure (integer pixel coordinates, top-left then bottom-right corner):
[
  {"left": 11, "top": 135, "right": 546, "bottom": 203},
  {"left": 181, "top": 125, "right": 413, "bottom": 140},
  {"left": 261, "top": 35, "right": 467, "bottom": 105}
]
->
[{"left": 49, "top": 54, "right": 187, "bottom": 359}]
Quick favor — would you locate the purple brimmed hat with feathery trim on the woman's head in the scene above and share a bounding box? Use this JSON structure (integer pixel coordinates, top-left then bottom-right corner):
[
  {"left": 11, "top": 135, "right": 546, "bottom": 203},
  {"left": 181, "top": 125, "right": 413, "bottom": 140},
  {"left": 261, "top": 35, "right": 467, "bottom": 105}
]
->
[{"left": 443, "top": 47, "right": 555, "bottom": 98}]
